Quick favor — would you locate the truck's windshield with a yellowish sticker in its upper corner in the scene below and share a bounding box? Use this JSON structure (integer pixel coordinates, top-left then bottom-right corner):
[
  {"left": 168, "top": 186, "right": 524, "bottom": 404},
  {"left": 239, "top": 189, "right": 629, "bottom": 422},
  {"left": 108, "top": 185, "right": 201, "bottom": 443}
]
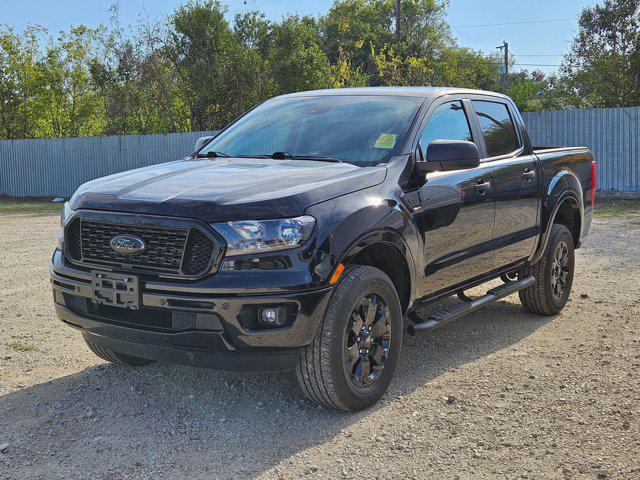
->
[{"left": 200, "top": 95, "right": 422, "bottom": 166}]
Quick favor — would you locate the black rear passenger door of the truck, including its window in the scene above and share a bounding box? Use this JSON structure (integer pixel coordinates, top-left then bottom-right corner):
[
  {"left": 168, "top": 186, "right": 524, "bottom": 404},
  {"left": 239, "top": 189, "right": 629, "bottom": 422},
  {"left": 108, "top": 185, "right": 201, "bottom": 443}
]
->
[{"left": 471, "top": 97, "right": 541, "bottom": 268}]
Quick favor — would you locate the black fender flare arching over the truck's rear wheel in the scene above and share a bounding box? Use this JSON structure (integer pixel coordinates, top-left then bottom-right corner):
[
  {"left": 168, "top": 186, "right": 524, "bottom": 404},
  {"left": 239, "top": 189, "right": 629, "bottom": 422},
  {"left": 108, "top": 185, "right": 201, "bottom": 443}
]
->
[{"left": 529, "top": 170, "right": 584, "bottom": 265}]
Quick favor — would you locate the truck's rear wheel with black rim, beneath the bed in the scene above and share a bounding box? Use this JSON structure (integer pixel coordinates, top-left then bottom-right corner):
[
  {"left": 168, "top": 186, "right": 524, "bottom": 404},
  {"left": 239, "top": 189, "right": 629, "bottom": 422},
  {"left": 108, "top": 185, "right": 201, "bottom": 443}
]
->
[{"left": 519, "top": 224, "right": 575, "bottom": 316}]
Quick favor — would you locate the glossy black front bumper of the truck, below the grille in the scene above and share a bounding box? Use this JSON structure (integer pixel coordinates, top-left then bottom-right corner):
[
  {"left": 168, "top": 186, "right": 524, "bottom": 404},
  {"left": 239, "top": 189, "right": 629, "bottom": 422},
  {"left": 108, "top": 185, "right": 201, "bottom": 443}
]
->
[{"left": 49, "top": 250, "right": 331, "bottom": 371}]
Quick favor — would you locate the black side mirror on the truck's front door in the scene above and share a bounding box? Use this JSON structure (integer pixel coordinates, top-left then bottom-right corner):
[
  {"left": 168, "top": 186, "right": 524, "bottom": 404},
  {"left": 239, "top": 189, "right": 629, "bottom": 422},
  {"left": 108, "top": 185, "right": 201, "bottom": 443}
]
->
[{"left": 416, "top": 140, "right": 480, "bottom": 174}]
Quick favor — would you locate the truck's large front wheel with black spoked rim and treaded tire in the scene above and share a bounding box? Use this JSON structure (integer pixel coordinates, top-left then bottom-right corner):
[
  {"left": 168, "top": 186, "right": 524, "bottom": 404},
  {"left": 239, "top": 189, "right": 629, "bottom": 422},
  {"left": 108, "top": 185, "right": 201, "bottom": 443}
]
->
[{"left": 296, "top": 265, "right": 403, "bottom": 412}]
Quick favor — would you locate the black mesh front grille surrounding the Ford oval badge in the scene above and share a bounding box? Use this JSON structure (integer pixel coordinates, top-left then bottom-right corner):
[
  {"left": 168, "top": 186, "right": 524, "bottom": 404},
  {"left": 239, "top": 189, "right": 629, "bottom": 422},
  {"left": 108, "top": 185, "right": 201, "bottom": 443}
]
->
[{"left": 65, "top": 215, "right": 221, "bottom": 277}]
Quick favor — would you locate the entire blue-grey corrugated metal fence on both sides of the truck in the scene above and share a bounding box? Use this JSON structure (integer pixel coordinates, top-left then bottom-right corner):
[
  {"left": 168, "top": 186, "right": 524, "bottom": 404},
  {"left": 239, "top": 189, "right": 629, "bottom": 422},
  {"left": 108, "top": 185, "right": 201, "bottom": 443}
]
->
[{"left": 0, "top": 107, "right": 640, "bottom": 197}]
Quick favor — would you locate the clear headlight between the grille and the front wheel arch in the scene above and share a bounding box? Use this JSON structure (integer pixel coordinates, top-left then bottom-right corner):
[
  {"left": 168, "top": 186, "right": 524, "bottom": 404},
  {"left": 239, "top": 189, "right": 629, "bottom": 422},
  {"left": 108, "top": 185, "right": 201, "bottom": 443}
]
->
[{"left": 213, "top": 215, "right": 316, "bottom": 256}]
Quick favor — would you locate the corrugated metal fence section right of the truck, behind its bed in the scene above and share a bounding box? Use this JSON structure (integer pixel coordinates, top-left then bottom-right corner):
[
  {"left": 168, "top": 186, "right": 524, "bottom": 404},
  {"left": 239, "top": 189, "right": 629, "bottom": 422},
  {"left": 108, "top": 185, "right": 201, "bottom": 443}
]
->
[{"left": 523, "top": 107, "right": 640, "bottom": 192}]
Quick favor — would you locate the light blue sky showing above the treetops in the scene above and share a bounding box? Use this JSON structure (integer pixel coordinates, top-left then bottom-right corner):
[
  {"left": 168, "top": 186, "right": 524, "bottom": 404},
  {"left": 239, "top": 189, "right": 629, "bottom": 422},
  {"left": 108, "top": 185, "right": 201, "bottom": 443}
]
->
[{"left": 0, "top": 0, "right": 594, "bottom": 73}]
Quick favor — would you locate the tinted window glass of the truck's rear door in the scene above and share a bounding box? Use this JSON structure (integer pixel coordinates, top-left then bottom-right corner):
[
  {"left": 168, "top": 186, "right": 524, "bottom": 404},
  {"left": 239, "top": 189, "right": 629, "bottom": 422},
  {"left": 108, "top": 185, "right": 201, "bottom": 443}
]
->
[{"left": 473, "top": 100, "right": 520, "bottom": 157}]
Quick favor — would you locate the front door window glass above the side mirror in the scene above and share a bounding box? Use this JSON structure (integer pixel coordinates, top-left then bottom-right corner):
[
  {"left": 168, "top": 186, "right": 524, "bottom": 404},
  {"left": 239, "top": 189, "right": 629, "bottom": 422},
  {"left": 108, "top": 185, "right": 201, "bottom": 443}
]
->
[{"left": 420, "top": 102, "right": 472, "bottom": 155}]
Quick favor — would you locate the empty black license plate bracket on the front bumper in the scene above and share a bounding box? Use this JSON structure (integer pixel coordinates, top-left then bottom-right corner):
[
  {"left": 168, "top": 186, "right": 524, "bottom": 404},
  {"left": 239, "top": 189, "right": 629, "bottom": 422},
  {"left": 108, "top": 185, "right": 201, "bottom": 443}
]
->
[{"left": 91, "top": 271, "right": 140, "bottom": 310}]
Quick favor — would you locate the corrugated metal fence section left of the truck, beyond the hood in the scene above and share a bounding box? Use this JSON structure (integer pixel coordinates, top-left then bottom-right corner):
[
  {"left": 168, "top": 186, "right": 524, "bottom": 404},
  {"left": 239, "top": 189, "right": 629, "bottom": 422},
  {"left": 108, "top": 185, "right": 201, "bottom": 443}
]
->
[{"left": 0, "top": 132, "right": 215, "bottom": 197}]
